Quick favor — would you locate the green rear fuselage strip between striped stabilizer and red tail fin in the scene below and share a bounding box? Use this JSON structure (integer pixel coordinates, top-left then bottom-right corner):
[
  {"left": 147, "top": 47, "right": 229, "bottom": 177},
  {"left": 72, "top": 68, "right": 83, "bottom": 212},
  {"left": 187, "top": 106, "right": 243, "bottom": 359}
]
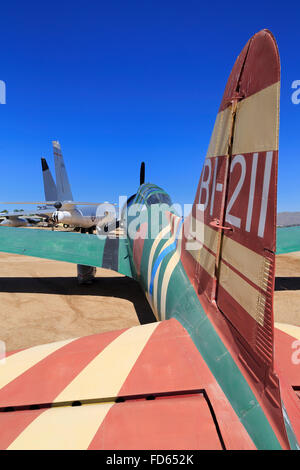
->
[{"left": 167, "top": 262, "right": 281, "bottom": 449}]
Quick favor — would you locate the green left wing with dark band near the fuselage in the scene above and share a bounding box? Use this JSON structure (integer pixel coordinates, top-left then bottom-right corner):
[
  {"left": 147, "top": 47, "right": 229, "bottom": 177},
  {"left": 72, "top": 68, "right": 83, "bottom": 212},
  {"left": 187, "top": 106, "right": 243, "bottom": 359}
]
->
[{"left": 0, "top": 227, "right": 132, "bottom": 277}]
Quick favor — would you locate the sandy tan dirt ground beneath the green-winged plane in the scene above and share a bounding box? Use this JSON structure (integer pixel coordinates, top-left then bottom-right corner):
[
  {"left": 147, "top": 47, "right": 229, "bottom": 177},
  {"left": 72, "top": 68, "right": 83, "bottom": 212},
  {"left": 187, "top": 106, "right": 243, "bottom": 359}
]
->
[{"left": 0, "top": 252, "right": 300, "bottom": 351}]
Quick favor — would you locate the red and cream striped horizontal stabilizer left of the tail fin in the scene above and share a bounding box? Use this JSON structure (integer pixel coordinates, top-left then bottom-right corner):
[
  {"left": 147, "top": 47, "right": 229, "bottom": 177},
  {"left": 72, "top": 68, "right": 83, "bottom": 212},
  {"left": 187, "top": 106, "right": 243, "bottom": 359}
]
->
[{"left": 0, "top": 319, "right": 254, "bottom": 449}]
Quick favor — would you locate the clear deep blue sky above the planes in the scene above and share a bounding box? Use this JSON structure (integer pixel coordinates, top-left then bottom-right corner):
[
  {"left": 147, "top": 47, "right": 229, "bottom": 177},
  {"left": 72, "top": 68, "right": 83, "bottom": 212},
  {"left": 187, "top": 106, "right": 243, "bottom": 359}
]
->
[{"left": 0, "top": 0, "right": 300, "bottom": 211}]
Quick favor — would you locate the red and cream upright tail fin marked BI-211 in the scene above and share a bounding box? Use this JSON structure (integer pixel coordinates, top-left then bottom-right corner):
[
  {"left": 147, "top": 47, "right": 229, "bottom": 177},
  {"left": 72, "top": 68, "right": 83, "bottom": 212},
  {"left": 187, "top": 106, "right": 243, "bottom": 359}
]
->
[{"left": 182, "top": 30, "right": 280, "bottom": 396}]
